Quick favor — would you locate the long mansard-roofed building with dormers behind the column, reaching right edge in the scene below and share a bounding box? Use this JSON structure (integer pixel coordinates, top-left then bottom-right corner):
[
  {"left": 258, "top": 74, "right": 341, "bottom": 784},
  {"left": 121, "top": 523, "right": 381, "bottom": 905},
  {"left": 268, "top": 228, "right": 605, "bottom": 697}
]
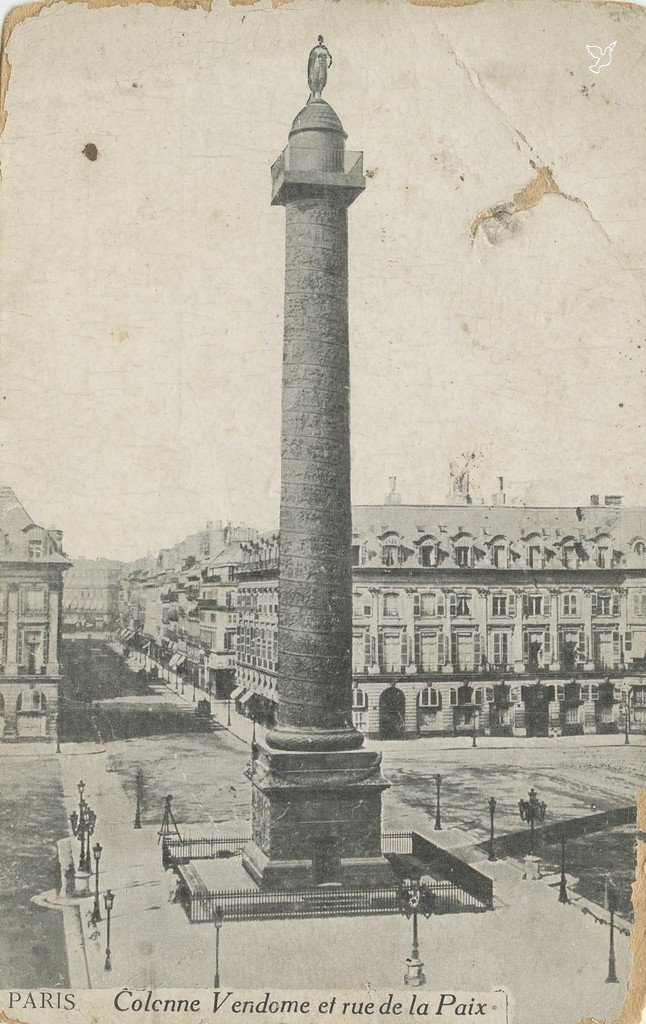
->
[{"left": 235, "top": 493, "right": 646, "bottom": 738}]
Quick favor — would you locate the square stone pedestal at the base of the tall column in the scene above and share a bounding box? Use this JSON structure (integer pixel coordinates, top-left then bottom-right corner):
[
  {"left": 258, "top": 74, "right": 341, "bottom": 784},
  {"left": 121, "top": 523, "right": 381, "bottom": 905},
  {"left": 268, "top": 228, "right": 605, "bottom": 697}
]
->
[{"left": 243, "top": 743, "right": 395, "bottom": 889}]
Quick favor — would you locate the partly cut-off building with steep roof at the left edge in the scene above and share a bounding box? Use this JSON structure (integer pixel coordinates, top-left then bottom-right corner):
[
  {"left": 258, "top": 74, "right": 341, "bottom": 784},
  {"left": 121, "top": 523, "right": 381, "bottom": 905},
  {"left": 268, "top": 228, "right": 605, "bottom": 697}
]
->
[{"left": 0, "top": 486, "right": 72, "bottom": 740}]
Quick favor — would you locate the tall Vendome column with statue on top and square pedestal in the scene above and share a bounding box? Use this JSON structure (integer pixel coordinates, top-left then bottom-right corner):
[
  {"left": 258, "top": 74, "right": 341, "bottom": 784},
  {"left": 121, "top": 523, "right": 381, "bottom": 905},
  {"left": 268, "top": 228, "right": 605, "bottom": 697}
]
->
[{"left": 244, "top": 36, "right": 391, "bottom": 888}]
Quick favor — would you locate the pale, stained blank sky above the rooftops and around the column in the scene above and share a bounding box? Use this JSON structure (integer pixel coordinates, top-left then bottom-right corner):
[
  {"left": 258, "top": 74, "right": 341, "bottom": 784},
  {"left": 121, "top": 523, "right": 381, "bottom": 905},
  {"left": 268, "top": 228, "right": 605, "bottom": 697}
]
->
[{"left": 0, "top": 0, "right": 646, "bottom": 559}]
